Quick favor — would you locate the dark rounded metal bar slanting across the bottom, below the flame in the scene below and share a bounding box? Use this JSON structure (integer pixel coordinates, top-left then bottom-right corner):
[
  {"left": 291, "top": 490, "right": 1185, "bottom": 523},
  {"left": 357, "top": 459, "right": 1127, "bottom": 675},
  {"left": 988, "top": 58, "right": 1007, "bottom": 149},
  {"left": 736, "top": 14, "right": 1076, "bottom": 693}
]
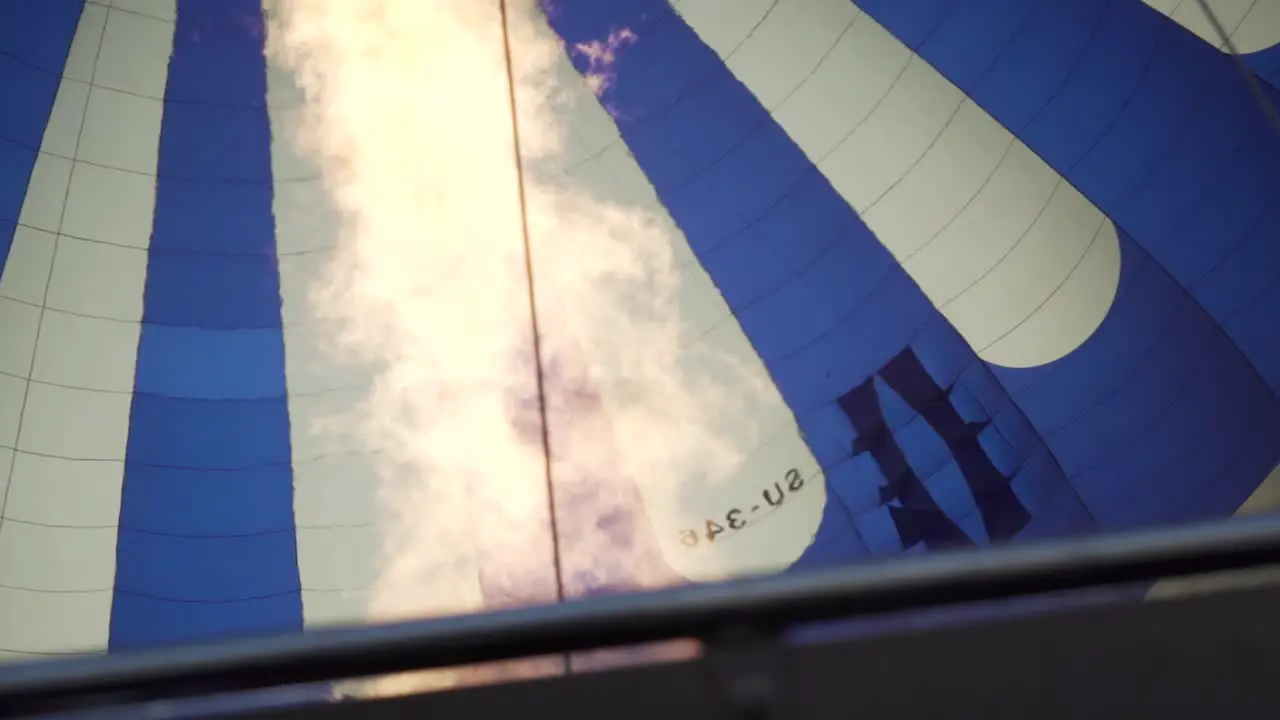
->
[{"left": 0, "top": 519, "right": 1280, "bottom": 716}]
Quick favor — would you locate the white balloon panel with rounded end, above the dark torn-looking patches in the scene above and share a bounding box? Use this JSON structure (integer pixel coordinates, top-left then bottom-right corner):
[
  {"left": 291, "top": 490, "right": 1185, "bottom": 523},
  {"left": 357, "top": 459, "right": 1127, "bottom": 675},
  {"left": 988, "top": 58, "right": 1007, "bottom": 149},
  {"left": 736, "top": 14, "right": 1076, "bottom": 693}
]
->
[{"left": 676, "top": 0, "right": 1120, "bottom": 366}]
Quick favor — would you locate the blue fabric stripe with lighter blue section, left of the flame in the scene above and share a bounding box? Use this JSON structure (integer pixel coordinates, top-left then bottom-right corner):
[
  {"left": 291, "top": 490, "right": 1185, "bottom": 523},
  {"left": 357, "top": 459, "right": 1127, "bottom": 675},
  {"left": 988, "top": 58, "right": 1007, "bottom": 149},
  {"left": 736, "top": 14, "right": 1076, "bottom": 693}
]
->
[{"left": 110, "top": 0, "right": 302, "bottom": 651}]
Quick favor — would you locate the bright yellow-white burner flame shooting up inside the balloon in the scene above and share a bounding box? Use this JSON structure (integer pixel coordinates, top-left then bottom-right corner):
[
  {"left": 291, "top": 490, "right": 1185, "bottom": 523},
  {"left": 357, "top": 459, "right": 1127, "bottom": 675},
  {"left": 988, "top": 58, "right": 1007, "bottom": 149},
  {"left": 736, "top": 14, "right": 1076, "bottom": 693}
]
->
[{"left": 268, "top": 0, "right": 764, "bottom": 691}]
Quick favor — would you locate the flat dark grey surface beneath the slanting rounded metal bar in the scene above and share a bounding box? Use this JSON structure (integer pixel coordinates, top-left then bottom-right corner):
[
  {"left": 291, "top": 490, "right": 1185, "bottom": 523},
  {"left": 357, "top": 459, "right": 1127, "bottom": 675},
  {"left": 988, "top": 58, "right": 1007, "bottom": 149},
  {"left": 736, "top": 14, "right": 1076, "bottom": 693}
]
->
[{"left": 249, "top": 579, "right": 1280, "bottom": 720}]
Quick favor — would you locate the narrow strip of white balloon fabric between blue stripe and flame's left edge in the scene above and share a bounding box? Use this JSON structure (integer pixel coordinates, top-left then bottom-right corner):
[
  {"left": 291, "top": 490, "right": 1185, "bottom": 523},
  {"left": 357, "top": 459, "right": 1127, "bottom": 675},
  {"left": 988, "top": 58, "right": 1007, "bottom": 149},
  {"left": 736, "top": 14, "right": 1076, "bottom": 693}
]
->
[{"left": 268, "top": 65, "right": 385, "bottom": 628}]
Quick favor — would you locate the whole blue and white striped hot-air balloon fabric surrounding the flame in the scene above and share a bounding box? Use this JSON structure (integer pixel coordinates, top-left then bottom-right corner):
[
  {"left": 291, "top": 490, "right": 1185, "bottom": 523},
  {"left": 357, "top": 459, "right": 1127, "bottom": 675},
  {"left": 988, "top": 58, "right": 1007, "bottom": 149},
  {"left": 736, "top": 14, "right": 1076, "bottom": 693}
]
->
[{"left": 0, "top": 0, "right": 1280, "bottom": 660}]
